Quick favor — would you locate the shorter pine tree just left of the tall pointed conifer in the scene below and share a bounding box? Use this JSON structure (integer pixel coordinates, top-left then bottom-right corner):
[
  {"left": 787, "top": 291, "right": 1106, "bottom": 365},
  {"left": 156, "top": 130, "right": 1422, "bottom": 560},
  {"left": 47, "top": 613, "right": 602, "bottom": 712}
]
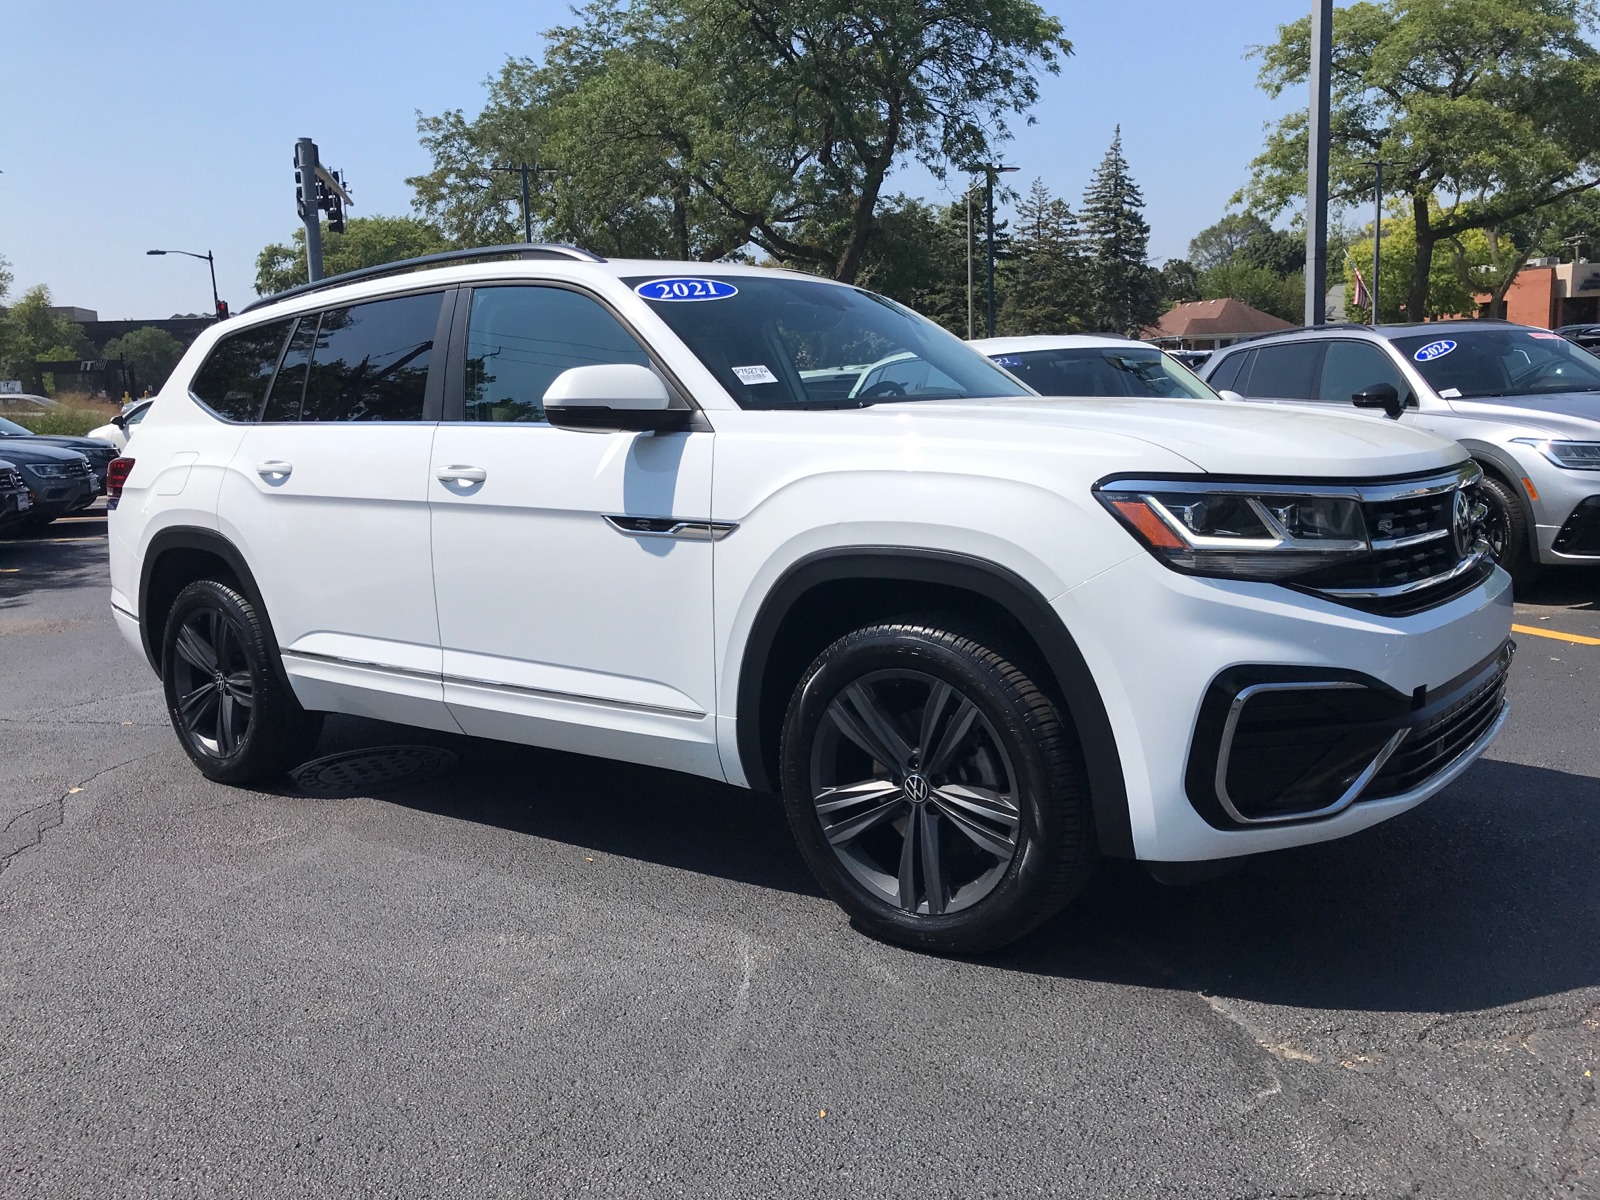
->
[{"left": 995, "top": 179, "right": 1093, "bottom": 336}]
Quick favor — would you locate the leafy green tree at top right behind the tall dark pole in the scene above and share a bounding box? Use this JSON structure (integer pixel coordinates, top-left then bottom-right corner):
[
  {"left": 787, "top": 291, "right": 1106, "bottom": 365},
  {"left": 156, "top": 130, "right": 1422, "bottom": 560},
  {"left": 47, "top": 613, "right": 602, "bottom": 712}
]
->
[{"left": 1235, "top": 0, "right": 1600, "bottom": 320}]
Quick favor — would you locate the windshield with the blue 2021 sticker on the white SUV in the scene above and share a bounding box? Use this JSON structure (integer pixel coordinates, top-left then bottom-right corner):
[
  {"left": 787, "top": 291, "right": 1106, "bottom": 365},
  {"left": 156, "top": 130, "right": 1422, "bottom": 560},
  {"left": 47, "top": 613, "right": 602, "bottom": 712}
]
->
[{"left": 624, "top": 275, "right": 1029, "bottom": 408}]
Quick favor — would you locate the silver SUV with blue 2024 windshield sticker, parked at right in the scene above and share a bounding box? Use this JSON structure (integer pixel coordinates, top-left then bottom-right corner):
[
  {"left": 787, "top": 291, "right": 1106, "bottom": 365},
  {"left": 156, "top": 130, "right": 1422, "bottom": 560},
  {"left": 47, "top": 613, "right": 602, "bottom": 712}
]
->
[{"left": 1203, "top": 320, "right": 1600, "bottom": 582}]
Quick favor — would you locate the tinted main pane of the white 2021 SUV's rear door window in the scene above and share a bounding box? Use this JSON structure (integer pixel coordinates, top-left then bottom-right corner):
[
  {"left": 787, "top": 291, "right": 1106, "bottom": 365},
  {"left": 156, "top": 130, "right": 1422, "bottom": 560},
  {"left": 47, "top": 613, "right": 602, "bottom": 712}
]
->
[{"left": 301, "top": 291, "right": 442, "bottom": 421}]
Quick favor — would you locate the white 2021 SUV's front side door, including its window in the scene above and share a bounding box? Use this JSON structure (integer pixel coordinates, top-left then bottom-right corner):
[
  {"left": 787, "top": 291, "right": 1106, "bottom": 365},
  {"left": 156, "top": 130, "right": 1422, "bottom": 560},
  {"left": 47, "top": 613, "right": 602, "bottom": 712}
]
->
[{"left": 429, "top": 285, "right": 722, "bottom": 778}]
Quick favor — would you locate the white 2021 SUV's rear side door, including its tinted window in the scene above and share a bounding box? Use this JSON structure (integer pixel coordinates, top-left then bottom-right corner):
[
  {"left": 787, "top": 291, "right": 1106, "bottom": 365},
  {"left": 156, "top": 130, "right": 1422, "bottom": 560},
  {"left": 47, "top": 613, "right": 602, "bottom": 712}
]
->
[{"left": 218, "top": 290, "right": 456, "bottom": 730}]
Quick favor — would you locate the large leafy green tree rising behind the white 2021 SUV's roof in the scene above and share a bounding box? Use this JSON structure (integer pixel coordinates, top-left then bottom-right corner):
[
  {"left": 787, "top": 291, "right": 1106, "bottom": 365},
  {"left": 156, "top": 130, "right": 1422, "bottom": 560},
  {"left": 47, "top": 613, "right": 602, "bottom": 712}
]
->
[{"left": 410, "top": 0, "right": 1070, "bottom": 282}]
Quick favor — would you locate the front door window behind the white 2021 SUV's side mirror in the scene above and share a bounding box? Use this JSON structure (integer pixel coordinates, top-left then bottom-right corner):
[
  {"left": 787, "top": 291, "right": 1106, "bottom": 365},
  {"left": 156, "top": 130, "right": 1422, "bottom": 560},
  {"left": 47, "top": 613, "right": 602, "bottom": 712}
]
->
[{"left": 464, "top": 286, "right": 650, "bottom": 422}]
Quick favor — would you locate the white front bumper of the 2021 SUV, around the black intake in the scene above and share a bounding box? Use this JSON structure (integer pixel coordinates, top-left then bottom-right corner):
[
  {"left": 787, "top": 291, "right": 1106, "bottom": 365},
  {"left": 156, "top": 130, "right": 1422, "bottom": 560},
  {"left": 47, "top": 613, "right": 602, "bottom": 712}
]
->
[{"left": 1054, "top": 555, "right": 1512, "bottom": 861}]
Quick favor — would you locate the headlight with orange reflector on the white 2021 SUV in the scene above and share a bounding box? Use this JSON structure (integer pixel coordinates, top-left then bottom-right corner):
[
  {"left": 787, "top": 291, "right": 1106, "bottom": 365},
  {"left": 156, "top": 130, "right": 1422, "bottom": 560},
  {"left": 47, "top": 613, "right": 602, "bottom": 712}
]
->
[{"left": 1094, "top": 480, "right": 1373, "bottom": 581}]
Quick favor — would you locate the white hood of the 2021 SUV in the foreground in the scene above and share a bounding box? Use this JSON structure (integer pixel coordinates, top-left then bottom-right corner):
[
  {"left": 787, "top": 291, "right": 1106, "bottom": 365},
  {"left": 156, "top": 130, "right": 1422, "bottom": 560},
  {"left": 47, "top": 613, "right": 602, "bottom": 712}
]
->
[{"left": 902, "top": 397, "right": 1467, "bottom": 478}]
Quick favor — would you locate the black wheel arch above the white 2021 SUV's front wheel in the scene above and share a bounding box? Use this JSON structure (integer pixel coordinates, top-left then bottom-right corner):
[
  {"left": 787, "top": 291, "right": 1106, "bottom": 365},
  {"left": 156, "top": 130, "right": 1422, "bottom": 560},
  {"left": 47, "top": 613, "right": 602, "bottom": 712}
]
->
[{"left": 736, "top": 547, "right": 1134, "bottom": 858}]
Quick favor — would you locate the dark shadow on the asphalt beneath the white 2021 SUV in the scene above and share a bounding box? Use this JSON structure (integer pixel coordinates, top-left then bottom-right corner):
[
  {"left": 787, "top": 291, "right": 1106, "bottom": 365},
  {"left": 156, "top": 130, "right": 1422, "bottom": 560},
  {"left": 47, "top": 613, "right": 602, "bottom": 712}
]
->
[{"left": 294, "top": 717, "right": 1600, "bottom": 1013}]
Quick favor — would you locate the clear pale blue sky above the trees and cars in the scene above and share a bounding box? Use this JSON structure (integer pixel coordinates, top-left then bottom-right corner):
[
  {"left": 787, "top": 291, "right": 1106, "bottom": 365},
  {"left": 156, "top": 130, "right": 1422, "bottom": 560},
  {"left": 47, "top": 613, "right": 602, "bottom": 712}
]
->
[{"left": 0, "top": 0, "right": 1309, "bottom": 318}]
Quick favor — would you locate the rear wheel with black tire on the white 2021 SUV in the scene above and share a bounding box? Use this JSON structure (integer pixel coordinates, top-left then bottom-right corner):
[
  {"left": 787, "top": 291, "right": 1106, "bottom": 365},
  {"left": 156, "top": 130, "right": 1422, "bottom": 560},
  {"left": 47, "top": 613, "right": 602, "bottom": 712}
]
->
[{"left": 162, "top": 579, "right": 322, "bottom": 784}]
